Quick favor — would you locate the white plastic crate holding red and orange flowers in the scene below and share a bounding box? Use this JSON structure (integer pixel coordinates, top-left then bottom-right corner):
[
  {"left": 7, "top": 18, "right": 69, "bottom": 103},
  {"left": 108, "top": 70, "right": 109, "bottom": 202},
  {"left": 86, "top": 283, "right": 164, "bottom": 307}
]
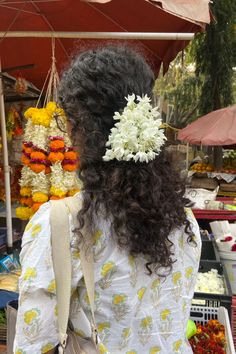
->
[{"left": 190, "top": 306, "right": 235, "bottom": 354}]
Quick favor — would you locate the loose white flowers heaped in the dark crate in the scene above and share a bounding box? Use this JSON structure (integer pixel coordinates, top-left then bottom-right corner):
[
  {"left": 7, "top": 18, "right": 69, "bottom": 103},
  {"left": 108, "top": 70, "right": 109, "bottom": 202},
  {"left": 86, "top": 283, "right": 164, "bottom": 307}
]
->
[{"left": 195, "top": 269, "right": 225, "bottom": 294}]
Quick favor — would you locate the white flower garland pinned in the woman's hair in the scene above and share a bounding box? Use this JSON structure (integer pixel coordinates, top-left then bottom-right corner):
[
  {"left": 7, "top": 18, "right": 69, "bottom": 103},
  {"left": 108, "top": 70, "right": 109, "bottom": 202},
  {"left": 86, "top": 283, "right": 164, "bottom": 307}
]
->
[{"left": 103, "top": 94, "right": 166, "bottom": 163}]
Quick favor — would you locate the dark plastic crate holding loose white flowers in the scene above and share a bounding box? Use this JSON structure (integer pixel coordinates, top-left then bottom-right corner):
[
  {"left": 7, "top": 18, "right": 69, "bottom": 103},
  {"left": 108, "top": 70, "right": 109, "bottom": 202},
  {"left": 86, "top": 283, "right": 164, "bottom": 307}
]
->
[{"left": 192, "top": 261, "right": 232, "bottom": 318}]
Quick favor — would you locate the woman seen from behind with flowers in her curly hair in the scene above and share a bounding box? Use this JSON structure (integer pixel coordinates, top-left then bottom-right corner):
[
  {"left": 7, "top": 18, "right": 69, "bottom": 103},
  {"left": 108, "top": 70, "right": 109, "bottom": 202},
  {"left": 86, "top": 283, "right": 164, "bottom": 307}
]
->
[{"left": 15, "top": 46, "right": 201, "bottom": 354}]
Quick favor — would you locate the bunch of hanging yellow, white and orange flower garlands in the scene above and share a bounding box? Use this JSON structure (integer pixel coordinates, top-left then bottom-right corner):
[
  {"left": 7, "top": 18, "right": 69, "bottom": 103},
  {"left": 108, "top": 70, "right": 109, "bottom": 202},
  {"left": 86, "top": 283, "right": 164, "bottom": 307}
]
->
[{"left": 16, "top": 102, "right": 80, "bottom": 220}]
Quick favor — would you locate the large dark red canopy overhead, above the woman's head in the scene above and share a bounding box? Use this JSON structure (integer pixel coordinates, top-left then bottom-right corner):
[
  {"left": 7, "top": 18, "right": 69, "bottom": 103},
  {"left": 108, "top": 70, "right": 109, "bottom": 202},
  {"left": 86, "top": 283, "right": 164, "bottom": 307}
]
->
[{"left": 0, "top": 0, "right": 210, "bottom": 87}]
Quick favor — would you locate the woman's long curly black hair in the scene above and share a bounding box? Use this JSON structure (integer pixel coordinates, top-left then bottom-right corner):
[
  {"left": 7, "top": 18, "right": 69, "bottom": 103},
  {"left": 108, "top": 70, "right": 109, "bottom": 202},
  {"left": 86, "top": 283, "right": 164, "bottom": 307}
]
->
[{"left": 59, "top": 46, "right": 192, "bottom": 273}]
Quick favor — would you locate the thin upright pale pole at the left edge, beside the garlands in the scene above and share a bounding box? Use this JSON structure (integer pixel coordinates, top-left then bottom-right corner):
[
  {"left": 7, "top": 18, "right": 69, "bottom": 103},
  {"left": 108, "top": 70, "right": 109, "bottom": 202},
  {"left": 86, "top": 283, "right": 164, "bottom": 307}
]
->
[{"left": 0, "top": 61, "right": 13, "bottom": 253}]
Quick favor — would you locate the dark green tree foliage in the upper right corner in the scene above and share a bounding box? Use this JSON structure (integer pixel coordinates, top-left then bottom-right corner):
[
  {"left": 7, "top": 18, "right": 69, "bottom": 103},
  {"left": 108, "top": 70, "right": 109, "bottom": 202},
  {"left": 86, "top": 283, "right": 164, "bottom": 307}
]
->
[{"left": 192, "top": 0, "right": 236, "bottom": 114}]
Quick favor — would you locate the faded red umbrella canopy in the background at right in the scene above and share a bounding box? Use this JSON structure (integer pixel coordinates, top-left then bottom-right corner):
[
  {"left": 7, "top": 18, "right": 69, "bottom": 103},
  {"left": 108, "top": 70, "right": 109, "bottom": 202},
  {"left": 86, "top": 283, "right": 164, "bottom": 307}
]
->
[{"left": 178, "top": 105, "right": 236, "bottom": 146}]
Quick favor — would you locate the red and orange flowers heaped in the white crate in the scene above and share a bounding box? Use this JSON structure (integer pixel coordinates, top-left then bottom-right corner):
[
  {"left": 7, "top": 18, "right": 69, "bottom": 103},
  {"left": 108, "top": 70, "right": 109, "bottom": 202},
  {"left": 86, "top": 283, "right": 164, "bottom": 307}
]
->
[{"left": 189, "top": 320, "right": 226, "bottom": 354}]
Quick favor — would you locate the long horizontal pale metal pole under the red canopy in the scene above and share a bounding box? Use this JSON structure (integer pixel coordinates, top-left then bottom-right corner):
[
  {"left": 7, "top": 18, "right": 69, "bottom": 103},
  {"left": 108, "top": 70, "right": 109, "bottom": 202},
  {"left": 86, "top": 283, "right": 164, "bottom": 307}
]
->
[{"left": 0, "top": 31, "right": 194, "bottom": 41}]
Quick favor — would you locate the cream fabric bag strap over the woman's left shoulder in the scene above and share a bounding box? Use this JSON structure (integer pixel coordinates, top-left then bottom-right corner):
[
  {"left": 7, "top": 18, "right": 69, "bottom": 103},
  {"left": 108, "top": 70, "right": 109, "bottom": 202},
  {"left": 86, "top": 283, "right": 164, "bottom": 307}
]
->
[{"left": 50, "top": 197, "right": 96, "bottom": 348}]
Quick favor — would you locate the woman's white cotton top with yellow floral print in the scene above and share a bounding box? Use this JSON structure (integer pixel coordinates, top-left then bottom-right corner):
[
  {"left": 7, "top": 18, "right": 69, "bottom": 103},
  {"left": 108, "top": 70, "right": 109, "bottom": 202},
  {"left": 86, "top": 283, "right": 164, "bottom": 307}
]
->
[{"left": 14, "top": 196, "right": 201, "bottom": 354}]
